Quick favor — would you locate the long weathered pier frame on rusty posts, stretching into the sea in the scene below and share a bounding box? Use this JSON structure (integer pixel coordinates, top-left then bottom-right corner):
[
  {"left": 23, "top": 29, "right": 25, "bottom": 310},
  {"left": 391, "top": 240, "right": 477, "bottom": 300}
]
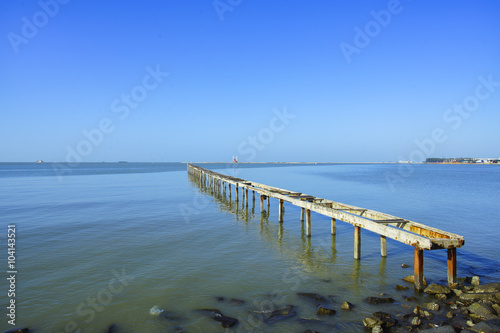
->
[{"left": 187, "top": 164, "right": 464, "bottom": 291}]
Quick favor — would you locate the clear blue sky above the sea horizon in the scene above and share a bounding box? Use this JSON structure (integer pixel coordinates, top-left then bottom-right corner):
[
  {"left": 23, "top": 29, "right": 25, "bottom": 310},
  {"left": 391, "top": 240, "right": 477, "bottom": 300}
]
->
[{"left": 0, "top": 0, "right": 500, "bottom": 162}]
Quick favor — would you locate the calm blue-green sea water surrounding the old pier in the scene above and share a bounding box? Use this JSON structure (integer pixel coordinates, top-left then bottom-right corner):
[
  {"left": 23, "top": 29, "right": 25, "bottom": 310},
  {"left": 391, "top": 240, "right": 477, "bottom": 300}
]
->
[{"left": 0, "top": 163, "right": 500, "bottom": 333}]
